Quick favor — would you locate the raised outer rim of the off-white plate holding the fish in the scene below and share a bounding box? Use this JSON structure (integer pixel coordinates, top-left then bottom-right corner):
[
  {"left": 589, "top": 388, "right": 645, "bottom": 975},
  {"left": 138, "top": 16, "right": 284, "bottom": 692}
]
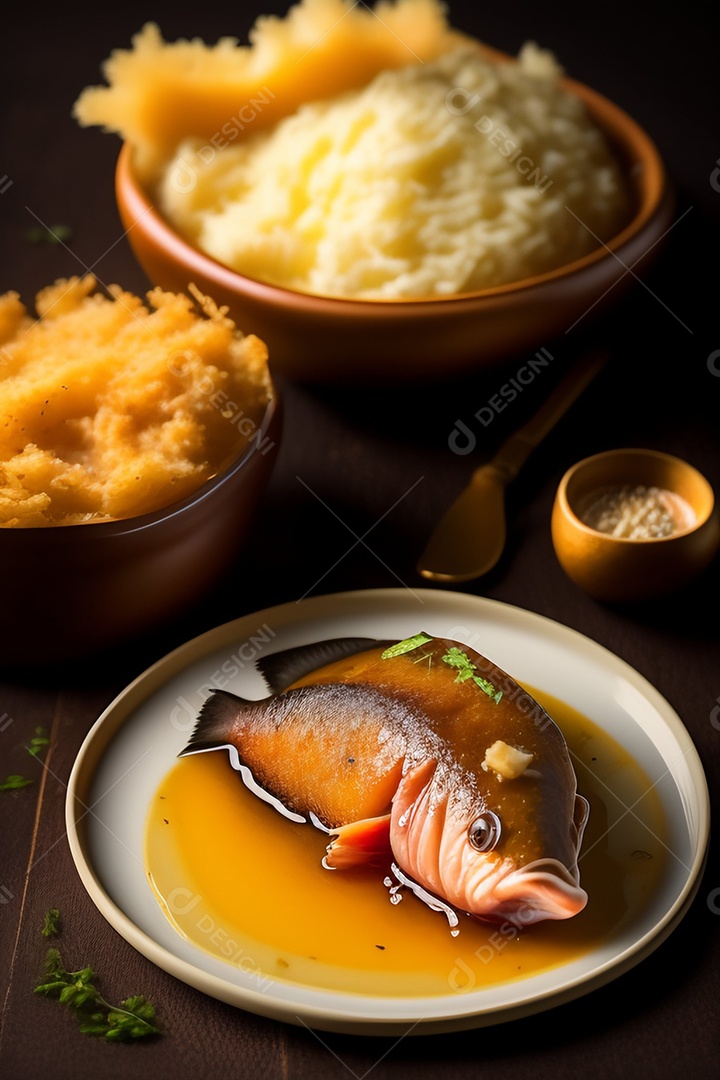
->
[{"left": 65, "top": 588, "right": 710, "bottom": 1036}]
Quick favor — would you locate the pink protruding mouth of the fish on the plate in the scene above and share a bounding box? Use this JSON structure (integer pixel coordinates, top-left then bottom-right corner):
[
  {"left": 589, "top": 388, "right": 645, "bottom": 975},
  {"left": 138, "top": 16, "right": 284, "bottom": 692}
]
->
[{"left": 493, "top": 859, "right": 587, "bottom": 927}]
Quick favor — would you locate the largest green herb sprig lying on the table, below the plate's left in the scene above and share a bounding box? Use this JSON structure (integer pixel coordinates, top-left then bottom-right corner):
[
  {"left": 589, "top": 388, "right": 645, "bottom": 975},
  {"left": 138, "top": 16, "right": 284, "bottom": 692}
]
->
[{"left": 35, "top": 950, "right": 160, "bottom": 1042}]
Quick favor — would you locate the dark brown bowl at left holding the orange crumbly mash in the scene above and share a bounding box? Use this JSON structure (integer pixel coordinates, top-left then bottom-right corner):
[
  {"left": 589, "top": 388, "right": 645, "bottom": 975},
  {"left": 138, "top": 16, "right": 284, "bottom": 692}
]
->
[{"left": 0, "top": 394, "right": 281, "bottom": 672}]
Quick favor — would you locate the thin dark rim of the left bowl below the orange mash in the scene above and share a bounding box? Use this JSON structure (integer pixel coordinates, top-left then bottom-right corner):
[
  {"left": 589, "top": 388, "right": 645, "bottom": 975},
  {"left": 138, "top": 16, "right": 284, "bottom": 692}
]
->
[{"left": 0, "top": 390, "right": 282, "bottom": 544}]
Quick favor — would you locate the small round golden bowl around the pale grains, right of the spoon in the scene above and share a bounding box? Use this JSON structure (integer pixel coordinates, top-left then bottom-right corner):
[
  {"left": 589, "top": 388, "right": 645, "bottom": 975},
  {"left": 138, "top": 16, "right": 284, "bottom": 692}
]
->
[{"left": 552, "top": 449, "right": 720, "bottom": 603}]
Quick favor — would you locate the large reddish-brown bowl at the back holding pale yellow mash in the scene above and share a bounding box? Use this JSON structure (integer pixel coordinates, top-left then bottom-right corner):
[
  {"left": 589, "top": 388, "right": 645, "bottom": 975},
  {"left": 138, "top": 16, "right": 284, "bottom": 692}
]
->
[{"left": 116, "top": 56, "right": 673, "bottom": 384}]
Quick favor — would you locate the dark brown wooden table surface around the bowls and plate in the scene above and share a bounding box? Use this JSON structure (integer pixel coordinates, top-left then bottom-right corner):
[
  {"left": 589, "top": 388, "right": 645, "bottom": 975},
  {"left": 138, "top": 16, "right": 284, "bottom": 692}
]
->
[{"left": 0, "top": 2, "right": 720, "bottom": 1080}]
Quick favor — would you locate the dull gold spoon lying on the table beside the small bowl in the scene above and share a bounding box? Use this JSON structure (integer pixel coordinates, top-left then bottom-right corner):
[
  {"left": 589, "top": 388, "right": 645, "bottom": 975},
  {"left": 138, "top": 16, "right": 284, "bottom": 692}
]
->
[{"left": 418, "top": 350, "right": 607, "bottom": 582}]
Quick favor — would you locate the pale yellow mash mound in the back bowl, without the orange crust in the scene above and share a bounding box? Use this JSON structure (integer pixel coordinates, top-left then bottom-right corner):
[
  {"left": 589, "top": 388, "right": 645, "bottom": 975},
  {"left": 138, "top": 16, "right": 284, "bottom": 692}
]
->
[{"left": 160, "top": 48, "right": 627, "bottom": 299}]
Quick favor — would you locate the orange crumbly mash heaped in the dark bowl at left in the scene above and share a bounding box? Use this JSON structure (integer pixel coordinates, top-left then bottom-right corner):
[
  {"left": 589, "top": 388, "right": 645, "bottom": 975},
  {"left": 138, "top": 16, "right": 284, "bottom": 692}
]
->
[{"left": 0, "top": 274, "right": 272, "bottom": 527}]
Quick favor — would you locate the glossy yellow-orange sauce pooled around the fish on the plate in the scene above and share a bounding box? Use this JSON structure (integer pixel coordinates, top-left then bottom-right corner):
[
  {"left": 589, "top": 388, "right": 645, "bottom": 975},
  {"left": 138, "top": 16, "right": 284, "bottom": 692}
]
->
[{"left": 146, "top": 690, "right": 667, "bottom": 996}]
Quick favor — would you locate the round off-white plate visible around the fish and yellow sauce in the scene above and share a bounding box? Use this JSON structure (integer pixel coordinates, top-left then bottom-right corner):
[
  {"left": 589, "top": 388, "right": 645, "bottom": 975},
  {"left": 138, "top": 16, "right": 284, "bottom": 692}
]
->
[{"left": 66, "top": 590, "right": 709, "bottom": 1035}]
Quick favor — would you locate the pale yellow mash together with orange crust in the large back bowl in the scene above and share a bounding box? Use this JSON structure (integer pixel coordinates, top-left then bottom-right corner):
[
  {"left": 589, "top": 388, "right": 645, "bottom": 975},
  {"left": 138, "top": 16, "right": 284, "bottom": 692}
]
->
[{"left": 77, "top": 0, "right": 631, "bottom": 299}]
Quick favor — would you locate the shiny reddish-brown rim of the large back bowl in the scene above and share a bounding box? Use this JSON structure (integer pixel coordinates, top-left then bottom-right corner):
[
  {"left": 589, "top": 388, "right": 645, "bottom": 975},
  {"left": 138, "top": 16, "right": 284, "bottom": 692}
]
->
[{"left": 116, "top": 42, "right": 671, "bottom": 319}]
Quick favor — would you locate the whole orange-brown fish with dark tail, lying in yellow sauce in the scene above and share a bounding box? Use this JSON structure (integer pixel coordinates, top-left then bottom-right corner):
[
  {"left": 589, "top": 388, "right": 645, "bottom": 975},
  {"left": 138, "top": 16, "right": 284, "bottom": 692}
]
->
[{"left": 178, "top": 631, "right": 589, "bottom": 927}]
